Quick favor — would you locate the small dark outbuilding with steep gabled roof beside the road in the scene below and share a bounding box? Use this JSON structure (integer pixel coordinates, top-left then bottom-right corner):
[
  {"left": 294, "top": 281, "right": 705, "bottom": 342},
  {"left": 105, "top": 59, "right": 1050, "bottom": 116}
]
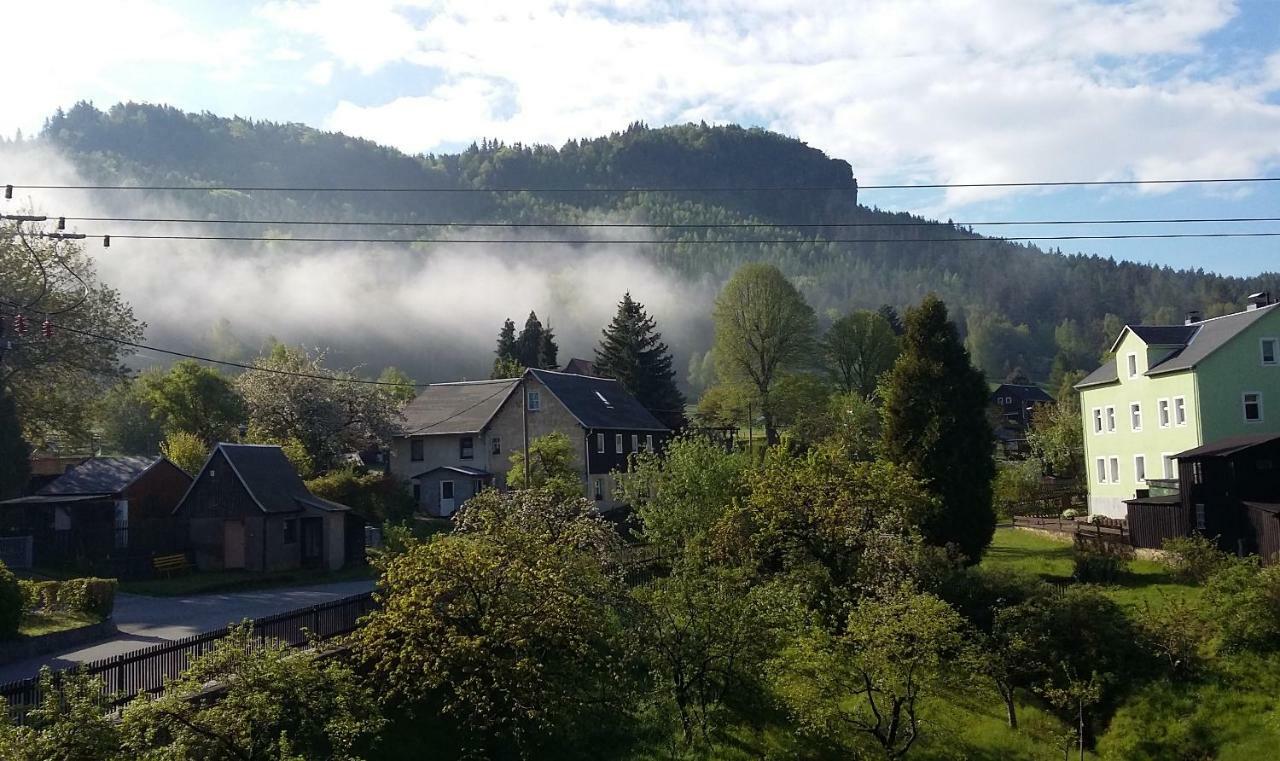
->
[{"left": 174, "top": 444, "right": 365, "bottom": 570}]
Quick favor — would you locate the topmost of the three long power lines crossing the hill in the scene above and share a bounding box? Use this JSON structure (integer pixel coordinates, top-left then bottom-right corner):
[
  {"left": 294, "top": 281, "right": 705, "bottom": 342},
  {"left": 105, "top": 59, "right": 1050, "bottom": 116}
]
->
[{"left": 9, "top": 177, "right": 1280, "bottom": 193}]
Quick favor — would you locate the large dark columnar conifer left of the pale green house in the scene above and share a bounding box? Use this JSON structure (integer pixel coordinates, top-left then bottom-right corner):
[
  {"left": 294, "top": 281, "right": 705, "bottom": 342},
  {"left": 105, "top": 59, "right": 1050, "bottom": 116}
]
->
[{"left": 879, "top": 295, "right": 996, "bottom": 563}]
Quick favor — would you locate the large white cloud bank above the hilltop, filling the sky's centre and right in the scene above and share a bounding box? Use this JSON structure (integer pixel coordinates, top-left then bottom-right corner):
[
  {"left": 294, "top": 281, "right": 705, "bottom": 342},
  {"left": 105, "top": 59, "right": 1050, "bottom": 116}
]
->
[{"left": 287, "top": 0, "right": 1280, "bottom": 205}]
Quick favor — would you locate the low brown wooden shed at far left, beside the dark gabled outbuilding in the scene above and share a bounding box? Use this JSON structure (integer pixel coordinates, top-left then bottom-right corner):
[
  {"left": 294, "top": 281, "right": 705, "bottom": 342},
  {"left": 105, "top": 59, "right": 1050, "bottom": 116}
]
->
[{"left": 0, "top": 457, "right": 191, "bottom": 577}]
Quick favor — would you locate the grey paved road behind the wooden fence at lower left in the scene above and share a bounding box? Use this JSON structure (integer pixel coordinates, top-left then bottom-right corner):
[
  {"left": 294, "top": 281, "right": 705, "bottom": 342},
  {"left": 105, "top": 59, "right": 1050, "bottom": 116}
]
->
[{"left": 0, "top": 581, "right": 374, "bottom": 683}]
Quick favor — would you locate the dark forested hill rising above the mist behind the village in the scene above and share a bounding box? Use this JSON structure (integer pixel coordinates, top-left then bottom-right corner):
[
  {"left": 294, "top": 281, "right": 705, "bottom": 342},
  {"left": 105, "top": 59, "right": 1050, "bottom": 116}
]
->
[{"left": 27, "top": 104, "right": 1280, "bottom": 380}]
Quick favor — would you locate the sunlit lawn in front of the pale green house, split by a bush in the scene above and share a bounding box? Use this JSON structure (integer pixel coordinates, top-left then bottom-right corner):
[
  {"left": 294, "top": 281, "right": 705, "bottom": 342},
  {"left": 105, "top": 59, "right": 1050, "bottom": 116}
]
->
[{"left": 982, "top": 528, "right": 1201, "bottom": 608}]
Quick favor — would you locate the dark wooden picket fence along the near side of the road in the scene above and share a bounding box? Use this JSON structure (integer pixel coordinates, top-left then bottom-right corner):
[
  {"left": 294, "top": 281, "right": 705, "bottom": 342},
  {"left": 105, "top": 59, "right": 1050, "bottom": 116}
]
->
[{"left": 0, "top": 592, "right": 374, "bottom": 723}]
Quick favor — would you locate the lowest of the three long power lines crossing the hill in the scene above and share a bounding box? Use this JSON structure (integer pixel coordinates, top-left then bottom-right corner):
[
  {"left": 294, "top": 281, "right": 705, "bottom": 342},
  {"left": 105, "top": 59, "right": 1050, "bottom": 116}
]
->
[{"left": 32, "top": 231, "right": 1280, "bottom": 246}]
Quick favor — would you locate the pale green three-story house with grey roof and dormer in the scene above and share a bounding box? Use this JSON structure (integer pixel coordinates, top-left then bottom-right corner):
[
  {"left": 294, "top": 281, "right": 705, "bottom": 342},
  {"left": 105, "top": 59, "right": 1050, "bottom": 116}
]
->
[{"left": 1075, "top": 294, "right": 1280, "bottom": 518}]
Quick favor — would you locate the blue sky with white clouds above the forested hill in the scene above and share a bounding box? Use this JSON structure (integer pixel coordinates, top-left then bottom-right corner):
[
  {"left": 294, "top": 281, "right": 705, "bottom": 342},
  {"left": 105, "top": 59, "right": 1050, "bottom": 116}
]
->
[{"left": 0, "top": 0, "right": 1280, "bottom": 274}]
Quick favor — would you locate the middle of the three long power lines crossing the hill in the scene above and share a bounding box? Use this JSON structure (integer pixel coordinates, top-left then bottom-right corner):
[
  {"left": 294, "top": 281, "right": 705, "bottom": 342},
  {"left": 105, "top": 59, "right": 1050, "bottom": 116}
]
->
[{"left": 49, "top": 216, "right": 1280, "bottom": 230}]
